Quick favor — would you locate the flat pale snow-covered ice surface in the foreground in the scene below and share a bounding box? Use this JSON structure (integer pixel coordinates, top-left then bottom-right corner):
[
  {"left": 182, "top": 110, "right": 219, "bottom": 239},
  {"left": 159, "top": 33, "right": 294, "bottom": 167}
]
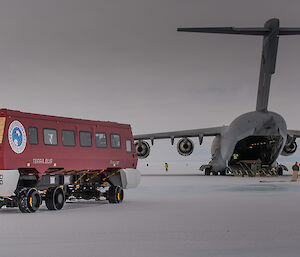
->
[{"left": 0, "top": 173, "right": 300, "bottom": 257}]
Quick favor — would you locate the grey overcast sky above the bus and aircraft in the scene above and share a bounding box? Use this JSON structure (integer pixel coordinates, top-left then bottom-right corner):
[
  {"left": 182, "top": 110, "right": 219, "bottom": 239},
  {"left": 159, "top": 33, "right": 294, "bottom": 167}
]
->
[{"left": 0, "top": 0, "right": 300, "bottom": 164}]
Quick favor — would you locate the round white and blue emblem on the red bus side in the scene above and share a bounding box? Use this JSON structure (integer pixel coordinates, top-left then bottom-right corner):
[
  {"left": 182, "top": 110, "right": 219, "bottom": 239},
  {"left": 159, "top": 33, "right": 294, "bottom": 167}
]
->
[{"left": 8, "top": 120, "right": 27, "bottom": 154}]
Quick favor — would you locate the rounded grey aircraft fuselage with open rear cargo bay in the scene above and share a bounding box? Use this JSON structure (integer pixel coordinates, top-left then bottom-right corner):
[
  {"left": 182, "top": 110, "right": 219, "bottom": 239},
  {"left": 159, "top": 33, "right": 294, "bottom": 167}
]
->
[{"left": 210, "top": 111, "right": 287, "bottom": 172}]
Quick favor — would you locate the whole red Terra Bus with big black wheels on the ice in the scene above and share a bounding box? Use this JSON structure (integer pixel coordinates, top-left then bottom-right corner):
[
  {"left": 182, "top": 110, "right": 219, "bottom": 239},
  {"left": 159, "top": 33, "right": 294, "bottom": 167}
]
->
[{"left": 0, "top": 109, "right": 140, "bottom": 212}]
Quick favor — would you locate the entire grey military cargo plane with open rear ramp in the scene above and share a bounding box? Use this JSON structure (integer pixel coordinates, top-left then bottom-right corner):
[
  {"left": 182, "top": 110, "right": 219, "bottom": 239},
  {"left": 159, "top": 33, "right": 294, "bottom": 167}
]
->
[{"left": 134, "top": 18, "right": 300, "bottom": 175}]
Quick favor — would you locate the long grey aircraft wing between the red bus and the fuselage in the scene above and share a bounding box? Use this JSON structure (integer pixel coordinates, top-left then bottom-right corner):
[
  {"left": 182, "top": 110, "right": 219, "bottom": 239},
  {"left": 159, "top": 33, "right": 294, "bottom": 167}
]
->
[{"left": 133, "top": 126, "right": 227, "bottom": 141}]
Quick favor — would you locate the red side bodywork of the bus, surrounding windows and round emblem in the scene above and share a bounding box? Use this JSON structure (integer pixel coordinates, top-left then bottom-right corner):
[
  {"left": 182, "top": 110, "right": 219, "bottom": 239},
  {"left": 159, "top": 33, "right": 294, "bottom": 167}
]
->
[{"left": 0, "top": 117, "right": 137, "bottom": 173}]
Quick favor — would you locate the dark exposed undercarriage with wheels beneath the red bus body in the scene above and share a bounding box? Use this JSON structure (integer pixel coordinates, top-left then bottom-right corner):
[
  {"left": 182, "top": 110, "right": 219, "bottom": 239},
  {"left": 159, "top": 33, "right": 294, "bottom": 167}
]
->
[{"left": 0, "top": 169, "right": 131, "bottom": 213}]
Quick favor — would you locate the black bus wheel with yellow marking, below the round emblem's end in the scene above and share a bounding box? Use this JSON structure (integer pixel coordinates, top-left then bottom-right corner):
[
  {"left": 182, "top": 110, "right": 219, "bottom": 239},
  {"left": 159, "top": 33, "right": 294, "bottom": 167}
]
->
[{"left": 18, "top": 188, "right": 42, "bottom": 213}]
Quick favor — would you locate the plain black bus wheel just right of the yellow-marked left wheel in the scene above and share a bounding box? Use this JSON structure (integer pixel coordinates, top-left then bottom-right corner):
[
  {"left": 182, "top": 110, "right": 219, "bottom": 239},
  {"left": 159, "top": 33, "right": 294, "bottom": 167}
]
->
[{"left": 45, "top": 187, "right": 66, "bottom": 211}]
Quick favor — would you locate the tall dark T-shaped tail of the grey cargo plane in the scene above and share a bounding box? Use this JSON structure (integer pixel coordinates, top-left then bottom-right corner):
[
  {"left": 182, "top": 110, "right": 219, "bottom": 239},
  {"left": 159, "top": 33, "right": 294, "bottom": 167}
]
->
[{"left": 177, "top": 18, "right": 300, "bottom": 111}]
